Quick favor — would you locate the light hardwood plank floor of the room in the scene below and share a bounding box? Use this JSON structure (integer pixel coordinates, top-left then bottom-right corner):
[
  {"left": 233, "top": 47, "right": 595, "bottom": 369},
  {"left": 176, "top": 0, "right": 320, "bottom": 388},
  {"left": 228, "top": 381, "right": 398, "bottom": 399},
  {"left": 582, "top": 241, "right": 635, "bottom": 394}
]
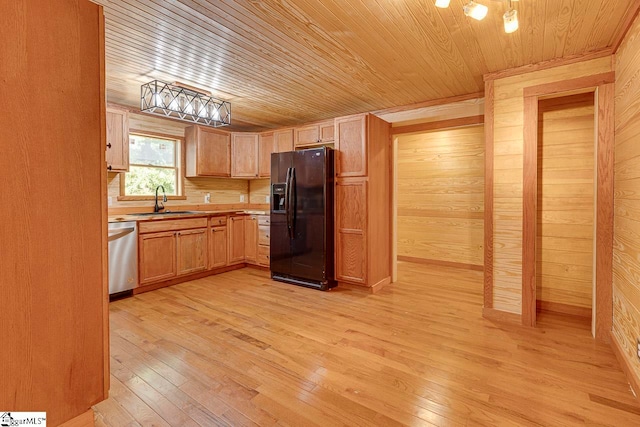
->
[{"left": 95, "top": 263, "right": 640, "bottom": 427}]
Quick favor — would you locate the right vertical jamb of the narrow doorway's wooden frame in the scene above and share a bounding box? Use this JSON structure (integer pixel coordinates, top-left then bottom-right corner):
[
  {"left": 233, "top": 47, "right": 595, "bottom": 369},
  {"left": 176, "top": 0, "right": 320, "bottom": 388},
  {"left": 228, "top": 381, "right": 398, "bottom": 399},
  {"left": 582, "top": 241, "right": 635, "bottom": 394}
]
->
[{"left": 595, "top": 83, "right": 615, "bottom": 341}]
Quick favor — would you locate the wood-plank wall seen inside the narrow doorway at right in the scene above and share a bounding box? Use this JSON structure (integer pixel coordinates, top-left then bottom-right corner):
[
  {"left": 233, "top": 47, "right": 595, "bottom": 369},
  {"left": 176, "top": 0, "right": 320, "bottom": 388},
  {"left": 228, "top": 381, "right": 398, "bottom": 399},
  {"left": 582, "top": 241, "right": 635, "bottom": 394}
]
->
[{"left": 536, "top": 93, "right": 595, "bottom": 317}]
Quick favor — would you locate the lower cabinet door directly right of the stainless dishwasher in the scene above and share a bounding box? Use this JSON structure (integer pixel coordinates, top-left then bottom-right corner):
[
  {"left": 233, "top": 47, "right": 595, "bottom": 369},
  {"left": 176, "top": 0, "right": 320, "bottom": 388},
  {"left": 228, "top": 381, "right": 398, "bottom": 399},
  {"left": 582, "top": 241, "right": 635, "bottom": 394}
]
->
[{"left": 138, "top": 231, "right": 177, "bottom": 285}]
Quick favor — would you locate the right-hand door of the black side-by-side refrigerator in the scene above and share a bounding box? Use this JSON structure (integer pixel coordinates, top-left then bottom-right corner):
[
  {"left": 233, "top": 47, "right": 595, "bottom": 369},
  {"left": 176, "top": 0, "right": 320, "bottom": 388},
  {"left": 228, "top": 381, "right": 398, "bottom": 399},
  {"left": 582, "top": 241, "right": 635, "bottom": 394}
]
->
[{"left": 290, "top": 149, "right": 327, "bottom": 282}]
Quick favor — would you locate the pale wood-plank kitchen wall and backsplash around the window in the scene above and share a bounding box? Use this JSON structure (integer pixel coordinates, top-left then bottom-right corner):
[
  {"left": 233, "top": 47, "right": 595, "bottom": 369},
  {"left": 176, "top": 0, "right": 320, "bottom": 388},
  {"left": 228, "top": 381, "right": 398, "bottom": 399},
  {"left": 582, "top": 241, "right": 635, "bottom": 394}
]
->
[{"left": 107, "top": 113, "right": 269, "bottom": 208}]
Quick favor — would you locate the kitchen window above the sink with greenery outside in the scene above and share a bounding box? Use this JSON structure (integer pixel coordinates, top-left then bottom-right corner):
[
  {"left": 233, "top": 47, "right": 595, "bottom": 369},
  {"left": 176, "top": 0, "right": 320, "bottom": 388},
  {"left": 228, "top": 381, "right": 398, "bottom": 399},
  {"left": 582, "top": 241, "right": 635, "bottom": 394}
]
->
[{"left": 120, "top": 134, "right": 181, "bottom": 198}]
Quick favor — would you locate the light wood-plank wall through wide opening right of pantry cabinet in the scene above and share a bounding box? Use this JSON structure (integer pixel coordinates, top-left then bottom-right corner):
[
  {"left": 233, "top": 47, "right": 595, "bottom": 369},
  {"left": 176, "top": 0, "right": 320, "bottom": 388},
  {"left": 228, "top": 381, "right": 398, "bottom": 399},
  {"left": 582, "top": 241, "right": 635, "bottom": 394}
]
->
[{"left": 397, "top": 126, "right": 484, "bottom": 267}]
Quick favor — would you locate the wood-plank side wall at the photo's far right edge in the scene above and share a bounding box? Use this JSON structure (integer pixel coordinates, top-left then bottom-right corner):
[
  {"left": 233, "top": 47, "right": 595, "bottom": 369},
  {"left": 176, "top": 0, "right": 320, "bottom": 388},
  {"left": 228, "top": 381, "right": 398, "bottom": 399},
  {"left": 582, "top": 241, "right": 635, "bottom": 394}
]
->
[{"left": 613, "top": 12, "right": 640, "bottom": 392}]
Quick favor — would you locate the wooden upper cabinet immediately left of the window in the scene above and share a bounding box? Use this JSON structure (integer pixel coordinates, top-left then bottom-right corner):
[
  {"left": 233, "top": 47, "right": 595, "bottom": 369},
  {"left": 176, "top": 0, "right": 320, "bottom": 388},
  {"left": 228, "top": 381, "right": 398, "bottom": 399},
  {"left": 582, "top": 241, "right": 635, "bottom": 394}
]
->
[{"left": 106, "top": 108, "right": 129, "bottom": 172}]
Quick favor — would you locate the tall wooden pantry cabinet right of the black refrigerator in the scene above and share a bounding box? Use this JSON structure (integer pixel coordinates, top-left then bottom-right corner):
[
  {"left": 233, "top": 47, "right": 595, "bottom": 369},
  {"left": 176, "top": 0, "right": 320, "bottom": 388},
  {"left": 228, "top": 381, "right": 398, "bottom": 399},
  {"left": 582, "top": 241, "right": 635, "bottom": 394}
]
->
[{"left": 335, "top": 114, "right": 391, "bottom": 291}]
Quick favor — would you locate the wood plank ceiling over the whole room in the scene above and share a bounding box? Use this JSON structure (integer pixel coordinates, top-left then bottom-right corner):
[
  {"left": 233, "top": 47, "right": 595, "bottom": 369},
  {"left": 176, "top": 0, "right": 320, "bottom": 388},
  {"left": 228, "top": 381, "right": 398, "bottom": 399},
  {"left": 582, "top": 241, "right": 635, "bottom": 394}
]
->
[{"left": 96, "top": 0, "right": 637, "bottom": 130}]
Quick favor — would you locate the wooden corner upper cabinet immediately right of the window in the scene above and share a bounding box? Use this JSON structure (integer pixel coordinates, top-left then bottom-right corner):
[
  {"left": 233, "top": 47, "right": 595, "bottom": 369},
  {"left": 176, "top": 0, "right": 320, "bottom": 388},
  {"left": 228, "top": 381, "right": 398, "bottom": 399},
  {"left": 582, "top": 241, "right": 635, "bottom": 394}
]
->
[{"left": 184, "top": 126, "right": 231, "bottom": 178}]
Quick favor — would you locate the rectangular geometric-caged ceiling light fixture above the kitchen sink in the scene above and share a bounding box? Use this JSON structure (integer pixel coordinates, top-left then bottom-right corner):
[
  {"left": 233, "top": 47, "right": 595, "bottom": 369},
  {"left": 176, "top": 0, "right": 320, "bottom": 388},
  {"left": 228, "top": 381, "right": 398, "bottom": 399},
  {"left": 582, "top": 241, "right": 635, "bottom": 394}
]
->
[{"left": 140, "top": 80, "right": 231, "bottom": 127}]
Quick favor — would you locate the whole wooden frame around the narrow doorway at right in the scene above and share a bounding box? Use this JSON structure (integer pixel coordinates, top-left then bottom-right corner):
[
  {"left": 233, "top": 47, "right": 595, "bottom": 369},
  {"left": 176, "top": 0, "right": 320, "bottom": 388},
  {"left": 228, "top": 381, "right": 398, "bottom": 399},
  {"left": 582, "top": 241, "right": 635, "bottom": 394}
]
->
[{"left": 522, "top": 72, "right": 615, "bottom": 341}]
